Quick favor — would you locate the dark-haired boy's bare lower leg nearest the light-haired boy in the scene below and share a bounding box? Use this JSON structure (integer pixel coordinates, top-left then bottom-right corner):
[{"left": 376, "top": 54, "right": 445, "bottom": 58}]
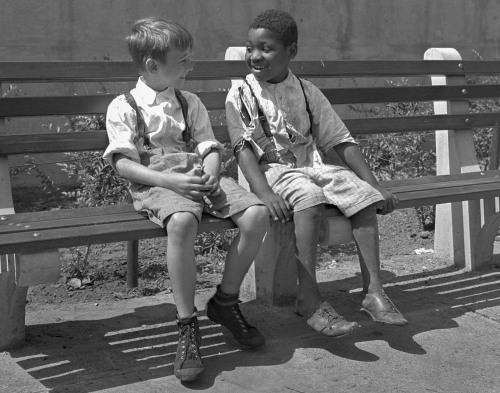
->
[{"left": 293, "top": 205, "right": 325, "bottom": 316}]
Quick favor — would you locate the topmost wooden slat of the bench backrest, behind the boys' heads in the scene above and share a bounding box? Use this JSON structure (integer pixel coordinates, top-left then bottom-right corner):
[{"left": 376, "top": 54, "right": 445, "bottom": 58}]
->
[{"left": 0, "top": 60, "right": 500, "bottom": 82}]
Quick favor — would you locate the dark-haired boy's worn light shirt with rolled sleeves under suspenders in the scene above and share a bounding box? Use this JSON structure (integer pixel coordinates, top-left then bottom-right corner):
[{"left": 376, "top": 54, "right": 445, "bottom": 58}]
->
[{"left": 226, "top": 71, "right": 356, "bottom": 167}]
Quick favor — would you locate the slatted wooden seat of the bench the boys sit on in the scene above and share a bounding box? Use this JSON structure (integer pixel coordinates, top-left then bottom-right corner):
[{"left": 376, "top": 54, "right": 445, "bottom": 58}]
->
[{"left": 0, "top": 170, "right": 500, "bottom": 254}]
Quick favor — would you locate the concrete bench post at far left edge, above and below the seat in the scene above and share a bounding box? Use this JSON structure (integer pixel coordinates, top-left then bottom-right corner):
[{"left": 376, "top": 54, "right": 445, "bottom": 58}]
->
[{"left": 0, "top": 80, "right": 28, "bottom": 351}]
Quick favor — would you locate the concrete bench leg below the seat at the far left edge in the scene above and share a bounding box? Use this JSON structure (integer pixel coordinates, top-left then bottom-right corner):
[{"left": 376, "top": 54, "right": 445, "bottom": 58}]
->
[{"left": 0, "top": 255, "right": 28, "bottom": 351}]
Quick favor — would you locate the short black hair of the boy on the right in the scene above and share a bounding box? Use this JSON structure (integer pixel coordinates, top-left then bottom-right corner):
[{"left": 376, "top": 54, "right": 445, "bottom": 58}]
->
[{"left": 249, "top": 9, "right": 298, "bottom": 47}]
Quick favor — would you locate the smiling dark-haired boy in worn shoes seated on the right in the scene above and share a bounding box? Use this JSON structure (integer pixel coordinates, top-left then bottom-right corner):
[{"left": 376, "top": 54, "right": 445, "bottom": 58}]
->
[{"left": 226, "top": 10, "right": 408, "bottom": 337}]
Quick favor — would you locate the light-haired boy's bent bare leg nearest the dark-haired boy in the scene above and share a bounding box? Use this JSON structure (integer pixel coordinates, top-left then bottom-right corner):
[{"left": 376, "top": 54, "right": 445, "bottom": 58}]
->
[{"left": 220, "top": 205, "right": 269, "bottom": 294}]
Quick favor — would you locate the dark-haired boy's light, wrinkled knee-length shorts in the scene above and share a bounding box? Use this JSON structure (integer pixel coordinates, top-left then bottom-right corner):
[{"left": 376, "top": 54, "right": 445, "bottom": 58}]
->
[{"left": 265, "top": 164, "right": 384, "bottom": 217}]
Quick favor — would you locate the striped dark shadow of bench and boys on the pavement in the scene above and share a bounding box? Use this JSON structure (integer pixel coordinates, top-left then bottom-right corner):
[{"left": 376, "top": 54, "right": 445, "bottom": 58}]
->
[{"left": 7, "top": 262, "right": 500, "bottom": 392}]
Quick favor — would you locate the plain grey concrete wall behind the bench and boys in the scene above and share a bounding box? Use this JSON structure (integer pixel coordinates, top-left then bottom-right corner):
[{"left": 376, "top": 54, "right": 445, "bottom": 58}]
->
[{"left": 0, "top": 0, "right": 500, "bottom": 187}]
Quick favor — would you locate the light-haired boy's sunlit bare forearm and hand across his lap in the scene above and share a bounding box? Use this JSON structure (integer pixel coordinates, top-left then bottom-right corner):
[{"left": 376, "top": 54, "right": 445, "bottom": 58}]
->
[{"left": 113, "top": 153, "right": 212, "bottom": 200}]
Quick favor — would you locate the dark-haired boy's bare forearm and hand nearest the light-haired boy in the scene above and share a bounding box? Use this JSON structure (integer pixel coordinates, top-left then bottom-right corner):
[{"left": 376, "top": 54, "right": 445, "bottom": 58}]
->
[{"left": 237, "top": 148, "right": 292, "bottom": 223}]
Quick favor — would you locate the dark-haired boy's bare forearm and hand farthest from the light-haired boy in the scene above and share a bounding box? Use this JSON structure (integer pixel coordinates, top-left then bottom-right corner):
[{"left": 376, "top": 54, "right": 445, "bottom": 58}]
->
[{"left": 327, "top": 143, "right": 398, "bottom": 214}]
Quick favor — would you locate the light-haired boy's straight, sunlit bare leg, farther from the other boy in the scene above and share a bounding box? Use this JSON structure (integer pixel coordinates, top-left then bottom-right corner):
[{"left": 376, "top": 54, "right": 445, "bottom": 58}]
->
[{"left": 167, "top": 212, "right": 198, "bottom": 319}]
